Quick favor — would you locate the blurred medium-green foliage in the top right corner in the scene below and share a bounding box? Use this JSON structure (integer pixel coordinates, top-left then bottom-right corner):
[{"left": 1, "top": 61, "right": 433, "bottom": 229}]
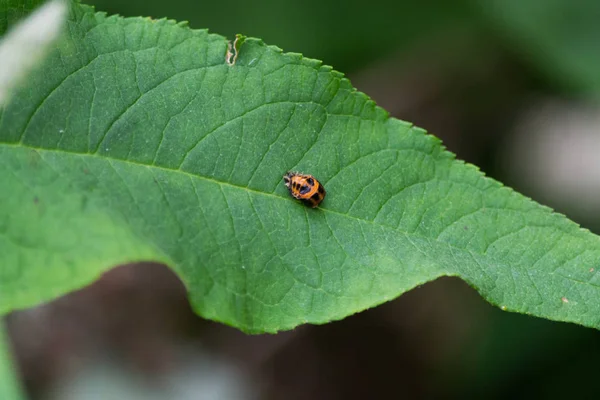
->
[{"left": 476, "top": 0, "right": 600, "bottom": 98}]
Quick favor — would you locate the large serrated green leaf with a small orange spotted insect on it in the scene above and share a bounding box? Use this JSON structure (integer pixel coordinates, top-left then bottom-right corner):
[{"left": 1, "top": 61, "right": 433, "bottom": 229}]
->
[{"left": 0, "top": 2, "right": 600, "bottom": 333}]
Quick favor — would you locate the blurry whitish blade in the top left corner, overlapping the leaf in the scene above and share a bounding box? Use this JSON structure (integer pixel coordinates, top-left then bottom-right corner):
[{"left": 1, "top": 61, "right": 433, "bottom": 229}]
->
[{"left": 0, "top": 0, "right": 67, "bottom": 106}]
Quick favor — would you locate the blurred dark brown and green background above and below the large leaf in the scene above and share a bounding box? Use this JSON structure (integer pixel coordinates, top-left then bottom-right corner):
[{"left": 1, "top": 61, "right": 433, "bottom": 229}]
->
[{"left": 7, "top": 0, "right": 600, "bottom": 400}]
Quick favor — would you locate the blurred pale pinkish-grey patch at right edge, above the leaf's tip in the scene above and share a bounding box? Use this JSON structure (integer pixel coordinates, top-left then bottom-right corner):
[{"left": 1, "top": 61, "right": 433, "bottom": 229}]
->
[{"left": 505, "top": 101, "right": 600, "bottom": 212}]
